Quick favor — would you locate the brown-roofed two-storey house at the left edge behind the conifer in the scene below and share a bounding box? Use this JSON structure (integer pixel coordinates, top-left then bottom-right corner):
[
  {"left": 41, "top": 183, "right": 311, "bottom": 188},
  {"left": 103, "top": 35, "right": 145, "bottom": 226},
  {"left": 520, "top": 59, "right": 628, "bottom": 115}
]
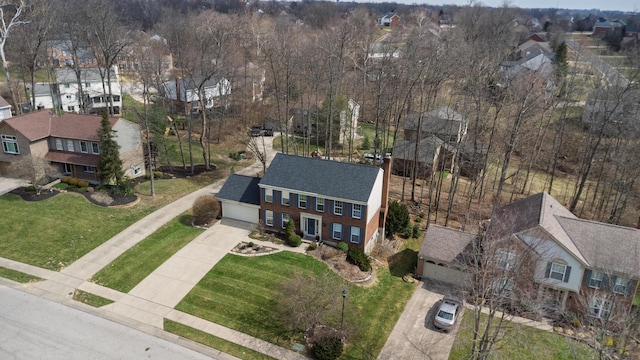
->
[{"left": 0, "top": 110, "right": 145, "bottom": 183}]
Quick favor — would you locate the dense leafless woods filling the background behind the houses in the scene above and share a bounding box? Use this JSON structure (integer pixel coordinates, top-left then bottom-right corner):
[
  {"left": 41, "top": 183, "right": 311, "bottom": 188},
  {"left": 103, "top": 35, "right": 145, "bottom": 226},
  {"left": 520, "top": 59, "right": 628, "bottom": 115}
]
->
[{"left": 5, "top": 0, "right": 640, "bottom": 227}]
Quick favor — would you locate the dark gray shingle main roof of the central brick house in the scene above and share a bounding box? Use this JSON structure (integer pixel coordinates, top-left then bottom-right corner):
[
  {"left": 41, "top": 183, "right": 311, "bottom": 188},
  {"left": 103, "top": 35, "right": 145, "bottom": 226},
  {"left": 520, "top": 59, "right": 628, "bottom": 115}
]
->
[{"left": 260, "top": 153, "right": 382, "bottom": 203}]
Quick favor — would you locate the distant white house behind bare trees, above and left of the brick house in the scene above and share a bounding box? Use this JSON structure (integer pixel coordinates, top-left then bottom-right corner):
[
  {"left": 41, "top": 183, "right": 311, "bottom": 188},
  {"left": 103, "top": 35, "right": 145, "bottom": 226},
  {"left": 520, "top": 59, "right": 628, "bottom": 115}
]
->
[{"left": 162, "top": 78, "right": 231, "bottom": 114}]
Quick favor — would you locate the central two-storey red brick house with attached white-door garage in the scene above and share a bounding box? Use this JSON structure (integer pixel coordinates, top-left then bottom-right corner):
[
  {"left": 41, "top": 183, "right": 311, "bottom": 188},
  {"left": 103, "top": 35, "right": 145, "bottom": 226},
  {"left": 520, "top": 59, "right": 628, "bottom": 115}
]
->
[{"left": 217, "top": 153, "right": 391, "bottom": 254}]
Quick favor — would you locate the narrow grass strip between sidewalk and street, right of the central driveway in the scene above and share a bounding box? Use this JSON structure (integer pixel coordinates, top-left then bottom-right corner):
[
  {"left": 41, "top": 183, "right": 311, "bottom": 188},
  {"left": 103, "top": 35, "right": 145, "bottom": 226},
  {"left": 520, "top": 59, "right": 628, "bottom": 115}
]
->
[{"left": 164, "top": 319, "right": 274, "bottom": 360}]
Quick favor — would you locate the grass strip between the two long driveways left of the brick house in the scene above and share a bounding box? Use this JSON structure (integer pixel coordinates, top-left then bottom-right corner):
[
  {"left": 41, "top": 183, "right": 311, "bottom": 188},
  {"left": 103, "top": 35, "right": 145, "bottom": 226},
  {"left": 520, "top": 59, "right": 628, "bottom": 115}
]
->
[{"left": 92, "top": 214, "right": 204, "bottom": 293}]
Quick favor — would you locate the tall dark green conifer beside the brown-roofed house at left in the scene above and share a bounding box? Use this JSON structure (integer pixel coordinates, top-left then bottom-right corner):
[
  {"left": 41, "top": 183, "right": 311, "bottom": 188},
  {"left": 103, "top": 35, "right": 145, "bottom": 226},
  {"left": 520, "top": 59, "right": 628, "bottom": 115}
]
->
[{"left": 98, "top": 111, "right": 124, "bottom": 184}]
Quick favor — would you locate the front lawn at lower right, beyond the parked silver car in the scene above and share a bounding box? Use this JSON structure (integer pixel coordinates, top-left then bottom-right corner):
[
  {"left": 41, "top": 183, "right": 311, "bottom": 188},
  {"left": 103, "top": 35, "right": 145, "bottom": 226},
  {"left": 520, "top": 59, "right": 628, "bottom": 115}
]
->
[{"left": 449, "top": 309, "right": 597, "bottom": 360}]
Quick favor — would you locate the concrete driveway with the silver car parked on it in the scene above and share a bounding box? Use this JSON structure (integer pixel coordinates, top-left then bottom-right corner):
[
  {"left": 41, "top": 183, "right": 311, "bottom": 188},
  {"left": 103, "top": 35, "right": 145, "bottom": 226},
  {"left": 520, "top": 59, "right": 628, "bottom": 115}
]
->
[{"left": 378, "top": 281, "right": 462, "bottom": 360}]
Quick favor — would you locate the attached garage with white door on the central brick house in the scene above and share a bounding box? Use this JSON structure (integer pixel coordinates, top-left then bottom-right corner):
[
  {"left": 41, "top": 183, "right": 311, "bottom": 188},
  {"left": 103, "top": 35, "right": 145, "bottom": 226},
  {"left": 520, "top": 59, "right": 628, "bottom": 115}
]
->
[{"left": 216, "top": 174, "right": 260, "bottom": 224}]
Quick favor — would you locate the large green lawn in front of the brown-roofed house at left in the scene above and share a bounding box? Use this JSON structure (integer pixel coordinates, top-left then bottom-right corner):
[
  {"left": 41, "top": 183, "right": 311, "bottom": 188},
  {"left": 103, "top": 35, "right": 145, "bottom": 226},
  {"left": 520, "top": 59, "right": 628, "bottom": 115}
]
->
[{"left": 0, "top": 179, "right": 216, "bottom": 271}]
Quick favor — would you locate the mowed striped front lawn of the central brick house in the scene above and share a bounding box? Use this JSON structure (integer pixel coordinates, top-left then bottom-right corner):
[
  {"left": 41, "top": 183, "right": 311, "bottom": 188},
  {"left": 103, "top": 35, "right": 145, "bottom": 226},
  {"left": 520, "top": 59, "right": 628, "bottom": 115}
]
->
[{"left": 176, "top": 252, "right": 414, "bottom": 359}]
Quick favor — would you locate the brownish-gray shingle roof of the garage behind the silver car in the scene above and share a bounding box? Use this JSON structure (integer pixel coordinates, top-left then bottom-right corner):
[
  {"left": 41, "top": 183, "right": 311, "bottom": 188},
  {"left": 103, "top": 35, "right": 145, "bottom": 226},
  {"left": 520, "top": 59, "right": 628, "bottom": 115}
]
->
[{"left": 419, "top": 224, "right": 476, "bottom": 263}]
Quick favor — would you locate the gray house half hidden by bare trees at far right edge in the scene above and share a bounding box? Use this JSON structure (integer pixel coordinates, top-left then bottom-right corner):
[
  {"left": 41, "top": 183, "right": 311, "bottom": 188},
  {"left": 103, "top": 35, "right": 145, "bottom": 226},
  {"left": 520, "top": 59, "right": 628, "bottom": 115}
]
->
[{"left": 582, "top": 87, "right": 640, "bottom": 137}]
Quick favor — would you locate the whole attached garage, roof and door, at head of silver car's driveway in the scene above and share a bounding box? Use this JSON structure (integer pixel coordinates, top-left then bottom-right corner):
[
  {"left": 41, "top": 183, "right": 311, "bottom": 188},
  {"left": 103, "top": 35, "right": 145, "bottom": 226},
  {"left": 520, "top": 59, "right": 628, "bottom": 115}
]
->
[{"left": 416, "top": 224, "right": 476, "bottom": 286}]
